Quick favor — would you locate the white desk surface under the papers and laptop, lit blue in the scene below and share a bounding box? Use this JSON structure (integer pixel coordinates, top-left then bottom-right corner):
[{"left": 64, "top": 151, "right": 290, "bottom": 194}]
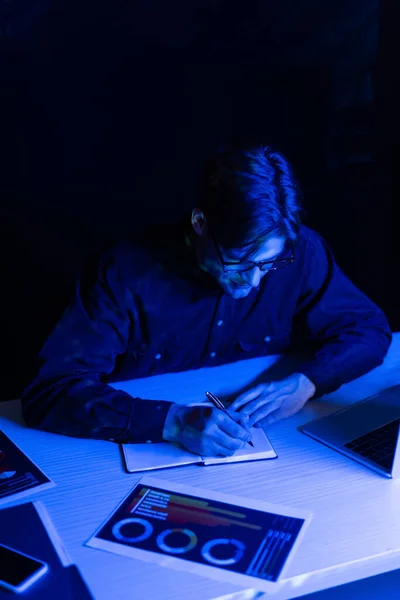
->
[{"left": 0, "top": 333, "right": 400, "bottom": 600}]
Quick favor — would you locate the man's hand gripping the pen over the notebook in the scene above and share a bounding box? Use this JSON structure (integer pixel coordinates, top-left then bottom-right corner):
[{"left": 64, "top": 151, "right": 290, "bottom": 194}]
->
[{"left": 163, "top": 404, "right": 251, "bottom": 456}]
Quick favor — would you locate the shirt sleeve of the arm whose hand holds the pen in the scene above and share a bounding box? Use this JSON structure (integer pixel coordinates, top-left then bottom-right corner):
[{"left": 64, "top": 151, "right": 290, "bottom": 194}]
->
[{"left": 21, "top": 246, "right": 172, "bottom": 443}]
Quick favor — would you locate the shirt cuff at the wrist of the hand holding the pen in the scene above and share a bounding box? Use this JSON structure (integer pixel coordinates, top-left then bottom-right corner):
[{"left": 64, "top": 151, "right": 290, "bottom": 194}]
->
[{"left": 123, "top": 398, "right": 173, "bottom": 444}]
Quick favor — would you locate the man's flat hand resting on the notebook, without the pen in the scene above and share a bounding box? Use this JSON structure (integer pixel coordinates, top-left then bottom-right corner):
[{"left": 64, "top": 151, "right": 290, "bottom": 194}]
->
[{"left": 229, "top": 373, "right": 315, "bottom": 427}]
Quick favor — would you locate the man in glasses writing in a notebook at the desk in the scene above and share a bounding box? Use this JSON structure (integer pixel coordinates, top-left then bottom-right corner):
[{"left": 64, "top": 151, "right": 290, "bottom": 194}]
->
[{"left": 22, "top": 147, "right": 391, "bottom": 456}]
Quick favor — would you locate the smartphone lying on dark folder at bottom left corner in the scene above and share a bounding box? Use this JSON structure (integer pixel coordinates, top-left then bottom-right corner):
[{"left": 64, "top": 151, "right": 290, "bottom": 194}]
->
[{"left": 0, "top": 544, "right": 49, "bottom": 594}]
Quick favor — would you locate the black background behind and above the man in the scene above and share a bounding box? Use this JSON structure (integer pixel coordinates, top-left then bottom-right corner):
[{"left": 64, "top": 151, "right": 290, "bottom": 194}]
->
[{"left": 0, "top": 0, "right": 399, "bottom": 399}]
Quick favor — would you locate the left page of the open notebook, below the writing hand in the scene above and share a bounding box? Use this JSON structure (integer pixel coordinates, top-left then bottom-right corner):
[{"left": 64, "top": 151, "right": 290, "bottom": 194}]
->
[{"left": 122, "top": 442, "right": 201, "bottom": 473}]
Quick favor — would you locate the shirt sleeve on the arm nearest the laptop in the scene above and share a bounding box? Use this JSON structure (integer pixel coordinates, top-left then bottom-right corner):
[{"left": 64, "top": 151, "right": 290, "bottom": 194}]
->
[{"left": 293, "top": 232, "right": 392, "bottom": 396}]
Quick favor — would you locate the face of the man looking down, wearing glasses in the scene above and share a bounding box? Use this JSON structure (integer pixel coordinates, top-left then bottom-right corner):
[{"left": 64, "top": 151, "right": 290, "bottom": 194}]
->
[{"left": 203, "top": 237, "right": 285, "bottom": 299}]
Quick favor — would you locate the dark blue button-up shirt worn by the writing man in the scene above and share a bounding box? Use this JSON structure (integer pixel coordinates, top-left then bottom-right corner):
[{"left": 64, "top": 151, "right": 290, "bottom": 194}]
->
[{"left": 22, "top": 224, "right": 391, "bottom": 442}]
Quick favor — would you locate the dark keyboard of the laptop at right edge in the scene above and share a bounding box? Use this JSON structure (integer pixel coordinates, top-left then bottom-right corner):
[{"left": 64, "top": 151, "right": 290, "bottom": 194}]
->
[{"left": 345, "top": 419, "right": 400, "bottom": 471}]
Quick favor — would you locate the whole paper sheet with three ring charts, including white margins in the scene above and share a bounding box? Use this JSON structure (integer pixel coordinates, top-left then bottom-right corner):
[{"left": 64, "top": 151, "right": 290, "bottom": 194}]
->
[{"left": 86, "top": 476, "right": 311, "bottom": 593}]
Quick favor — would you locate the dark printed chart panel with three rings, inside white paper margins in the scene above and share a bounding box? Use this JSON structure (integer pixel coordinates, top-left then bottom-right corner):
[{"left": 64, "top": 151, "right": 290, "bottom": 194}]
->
[{"left": 90, "top": 484, "right": 304, "bottom": 581}]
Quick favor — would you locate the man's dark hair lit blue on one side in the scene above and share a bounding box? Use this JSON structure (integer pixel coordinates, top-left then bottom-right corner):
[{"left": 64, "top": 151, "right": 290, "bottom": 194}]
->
[{"left": 198, "top": 146, "right": 301, "bottom": 248}]
